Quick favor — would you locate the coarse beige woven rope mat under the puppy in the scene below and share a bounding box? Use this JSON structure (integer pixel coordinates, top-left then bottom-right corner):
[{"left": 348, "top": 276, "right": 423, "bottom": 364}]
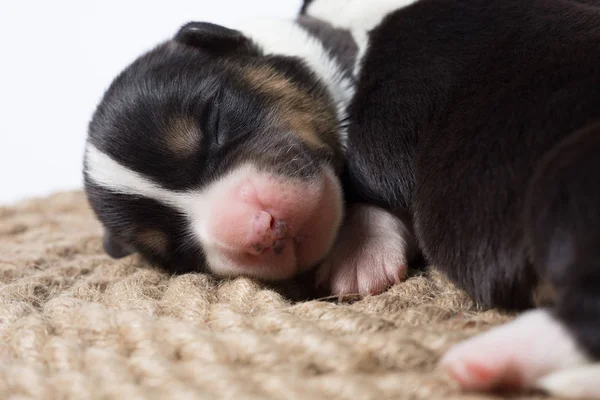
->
[{"left": 0, "top": 192, "right": 543, "bottom": 400}]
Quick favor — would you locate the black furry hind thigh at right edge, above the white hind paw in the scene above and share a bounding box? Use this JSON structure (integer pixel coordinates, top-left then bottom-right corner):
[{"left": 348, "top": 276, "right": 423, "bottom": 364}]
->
[{"left": 524, "top": 120, "right": 600, "bottom": 357}]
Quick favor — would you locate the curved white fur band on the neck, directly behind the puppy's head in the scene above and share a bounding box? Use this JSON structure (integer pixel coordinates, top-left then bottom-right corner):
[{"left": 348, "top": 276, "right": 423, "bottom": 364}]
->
[{"left": 235, "top": 19, "right": 354, "bottom": 147}]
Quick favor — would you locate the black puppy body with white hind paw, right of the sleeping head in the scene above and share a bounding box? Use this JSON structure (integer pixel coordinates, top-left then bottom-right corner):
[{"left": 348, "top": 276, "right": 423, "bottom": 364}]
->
[{"left": 303, "top": 0, "right": 600, "bottom": 398}]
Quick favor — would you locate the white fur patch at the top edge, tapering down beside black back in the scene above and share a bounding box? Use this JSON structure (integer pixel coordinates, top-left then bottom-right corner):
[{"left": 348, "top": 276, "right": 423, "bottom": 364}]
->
[{"left": 306, "top": 0, "right": 418, "bottom": 75}]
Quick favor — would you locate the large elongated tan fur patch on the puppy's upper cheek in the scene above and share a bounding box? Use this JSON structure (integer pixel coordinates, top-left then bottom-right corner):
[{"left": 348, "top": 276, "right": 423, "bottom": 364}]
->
[{"left": 244, "top": 66, "right": 339, "bottom": 155}]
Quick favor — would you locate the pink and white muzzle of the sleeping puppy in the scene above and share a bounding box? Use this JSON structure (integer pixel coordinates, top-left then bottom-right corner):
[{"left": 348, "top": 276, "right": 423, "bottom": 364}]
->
[{"left": 192, "top": 165, "right": 344, "bottom": 281}]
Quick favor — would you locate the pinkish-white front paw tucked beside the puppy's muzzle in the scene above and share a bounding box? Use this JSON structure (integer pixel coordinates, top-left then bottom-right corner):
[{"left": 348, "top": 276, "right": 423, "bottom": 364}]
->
[{"left": 317, "top": 204, "right": 416, "bottom": 297}]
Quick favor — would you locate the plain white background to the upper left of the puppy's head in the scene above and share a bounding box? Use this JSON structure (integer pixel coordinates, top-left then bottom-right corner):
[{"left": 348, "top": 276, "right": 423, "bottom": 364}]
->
[{"left": 0, "top": 0, "right": 301, "bottom": 204}]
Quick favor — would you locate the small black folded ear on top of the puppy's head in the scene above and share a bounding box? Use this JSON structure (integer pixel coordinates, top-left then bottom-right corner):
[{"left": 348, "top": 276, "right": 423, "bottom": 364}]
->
[{"left": 175, "top": 22, "right": 250, "bottom": 53}]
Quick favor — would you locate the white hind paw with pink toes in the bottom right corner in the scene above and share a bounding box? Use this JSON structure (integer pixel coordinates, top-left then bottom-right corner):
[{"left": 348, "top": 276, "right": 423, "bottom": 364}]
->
[{"left": 440, "top": 310, "right": 600, "bottom": 399}]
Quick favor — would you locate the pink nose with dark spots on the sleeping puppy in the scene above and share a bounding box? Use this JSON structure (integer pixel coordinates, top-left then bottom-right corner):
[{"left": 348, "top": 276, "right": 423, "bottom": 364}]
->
[{"left": 247, "top": 211, "right": 287, "bottom": 255}]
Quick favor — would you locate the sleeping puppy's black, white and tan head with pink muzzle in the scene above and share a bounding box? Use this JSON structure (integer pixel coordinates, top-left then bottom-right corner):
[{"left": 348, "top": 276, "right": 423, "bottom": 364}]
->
[{"left": 84, "top": 22, "right": 343, "bottom": 280}]
